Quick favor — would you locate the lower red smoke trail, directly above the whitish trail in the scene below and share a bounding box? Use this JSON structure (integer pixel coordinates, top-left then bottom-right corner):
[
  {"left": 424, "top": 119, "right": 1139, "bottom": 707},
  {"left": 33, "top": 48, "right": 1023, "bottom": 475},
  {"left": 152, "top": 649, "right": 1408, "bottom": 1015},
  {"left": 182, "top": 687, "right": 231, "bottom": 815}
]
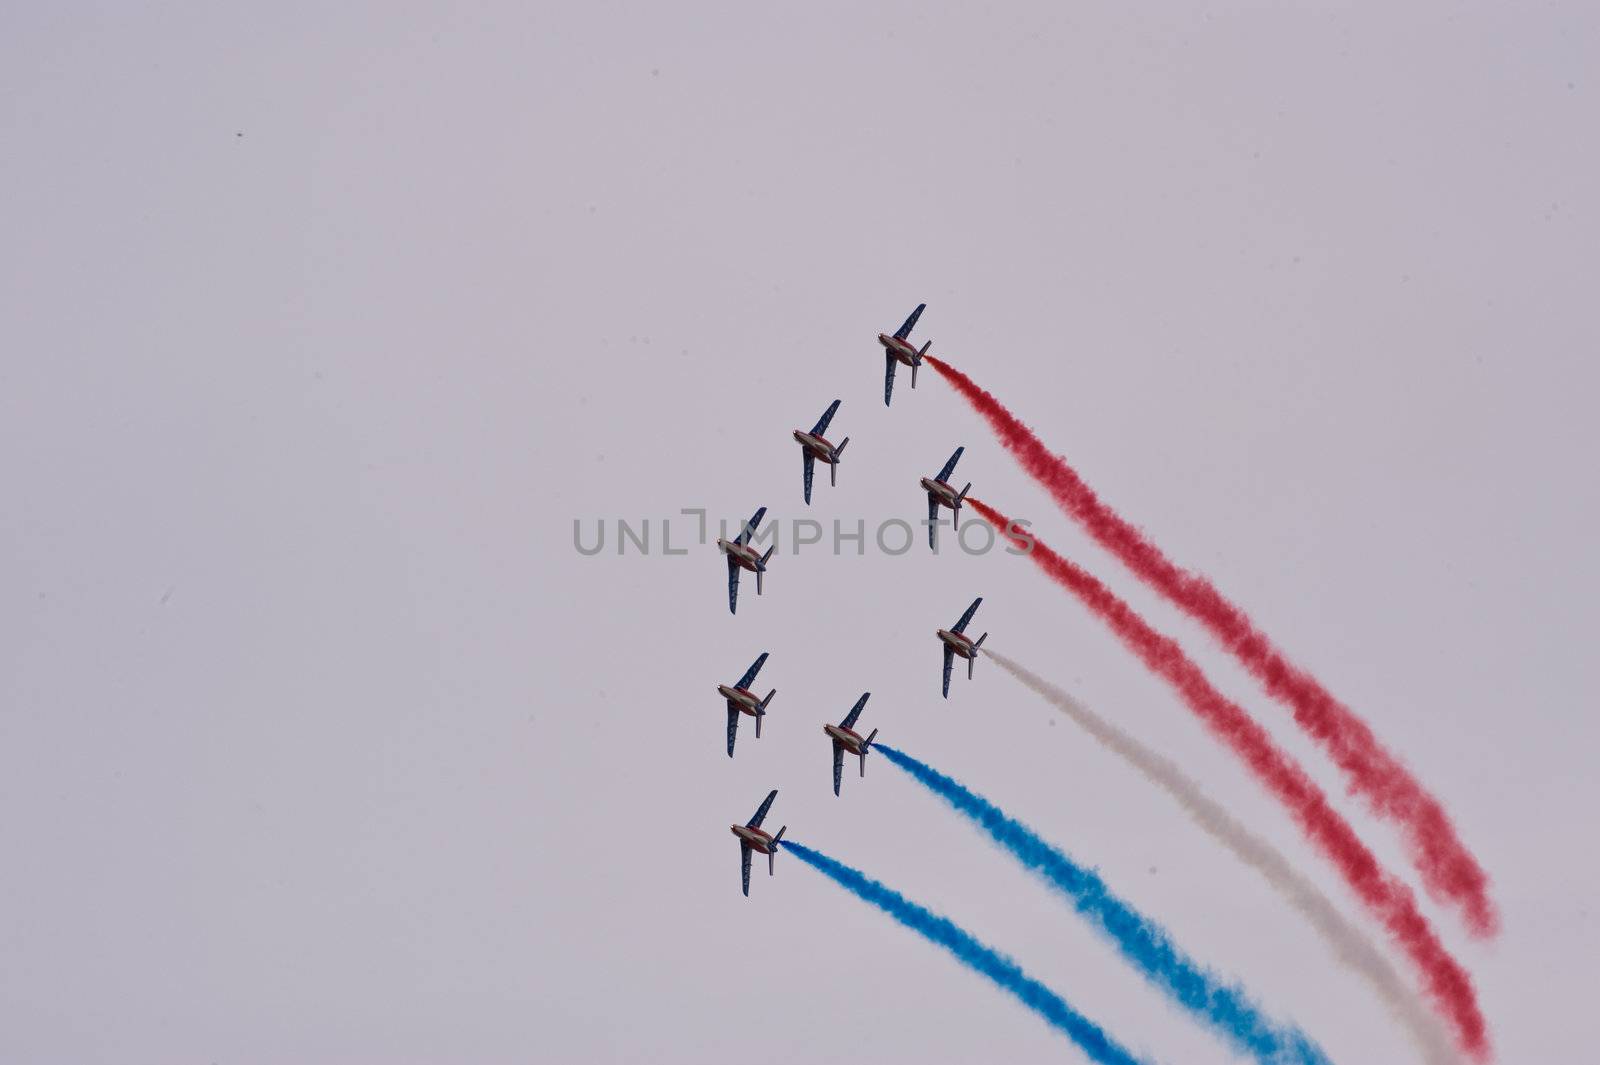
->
[{"left": 966, "top": 496, "right": 1490, "bottom": 1060}]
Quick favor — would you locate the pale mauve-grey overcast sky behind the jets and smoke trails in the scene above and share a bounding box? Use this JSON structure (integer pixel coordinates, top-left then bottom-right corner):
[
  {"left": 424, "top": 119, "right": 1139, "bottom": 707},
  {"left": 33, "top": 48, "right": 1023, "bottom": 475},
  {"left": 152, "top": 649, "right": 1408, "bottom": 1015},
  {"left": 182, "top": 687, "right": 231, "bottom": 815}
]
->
[{"left": 9, "top": 3, "right": 1600, "bottom": 1065}]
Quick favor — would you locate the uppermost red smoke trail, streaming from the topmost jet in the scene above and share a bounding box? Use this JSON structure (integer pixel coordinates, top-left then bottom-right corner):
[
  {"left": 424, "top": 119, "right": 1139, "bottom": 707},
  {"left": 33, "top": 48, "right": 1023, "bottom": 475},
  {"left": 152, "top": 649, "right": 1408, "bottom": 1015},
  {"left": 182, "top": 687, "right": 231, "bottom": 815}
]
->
[{"left": 925, "top": 355, "right": 1499, "bottom": 935}]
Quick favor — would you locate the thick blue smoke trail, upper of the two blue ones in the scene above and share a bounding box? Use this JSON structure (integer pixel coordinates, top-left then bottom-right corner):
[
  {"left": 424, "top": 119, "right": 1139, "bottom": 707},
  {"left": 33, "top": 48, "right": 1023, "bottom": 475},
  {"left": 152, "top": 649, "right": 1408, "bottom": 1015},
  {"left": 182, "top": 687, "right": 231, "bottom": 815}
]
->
[{"left": 872, "top": 742, "right": 1328, "bottom": 1065}]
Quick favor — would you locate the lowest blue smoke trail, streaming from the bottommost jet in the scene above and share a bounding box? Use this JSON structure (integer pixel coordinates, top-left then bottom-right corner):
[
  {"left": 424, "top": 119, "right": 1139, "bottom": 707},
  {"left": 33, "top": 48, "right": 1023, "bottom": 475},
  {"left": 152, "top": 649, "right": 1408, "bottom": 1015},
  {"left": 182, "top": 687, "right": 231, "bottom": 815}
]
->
[{"left": 779, "top": 840, "right": 1142, "bottom": 1065}]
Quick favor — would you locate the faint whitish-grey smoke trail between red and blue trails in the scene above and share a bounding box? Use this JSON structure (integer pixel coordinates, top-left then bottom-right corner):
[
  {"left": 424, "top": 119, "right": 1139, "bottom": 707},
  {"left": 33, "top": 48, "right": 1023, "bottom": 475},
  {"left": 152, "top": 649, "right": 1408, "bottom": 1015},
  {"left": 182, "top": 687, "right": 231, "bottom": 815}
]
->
[{"left": 984, "top": 648, "right": 1459, "bottom": 1065}]
